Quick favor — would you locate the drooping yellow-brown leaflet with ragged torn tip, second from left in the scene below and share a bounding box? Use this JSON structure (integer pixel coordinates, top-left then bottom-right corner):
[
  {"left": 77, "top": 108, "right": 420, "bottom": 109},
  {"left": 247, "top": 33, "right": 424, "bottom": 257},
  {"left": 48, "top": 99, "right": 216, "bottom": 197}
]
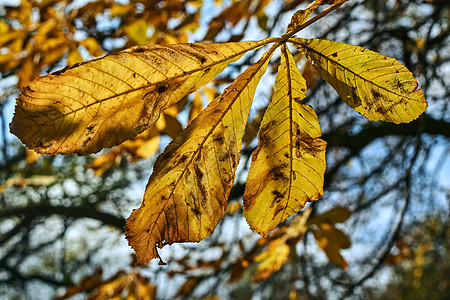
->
[{"left": 125, "top": 47, "right": 274, "bottom": 264}]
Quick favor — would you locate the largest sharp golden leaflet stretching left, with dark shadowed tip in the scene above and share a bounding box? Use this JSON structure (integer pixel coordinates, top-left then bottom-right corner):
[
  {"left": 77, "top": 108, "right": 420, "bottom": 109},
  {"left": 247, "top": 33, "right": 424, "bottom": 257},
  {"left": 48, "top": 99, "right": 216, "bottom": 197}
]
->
[{"left": 10, "top": 39, "right": 273, "bottom": 155}]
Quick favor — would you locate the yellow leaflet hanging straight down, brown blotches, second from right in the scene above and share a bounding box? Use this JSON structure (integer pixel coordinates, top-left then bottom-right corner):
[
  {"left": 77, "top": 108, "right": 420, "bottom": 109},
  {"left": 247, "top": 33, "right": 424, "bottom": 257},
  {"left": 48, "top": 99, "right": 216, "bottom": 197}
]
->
[{"left": 243, "top": 45, "right": 326, "bottom": 236}]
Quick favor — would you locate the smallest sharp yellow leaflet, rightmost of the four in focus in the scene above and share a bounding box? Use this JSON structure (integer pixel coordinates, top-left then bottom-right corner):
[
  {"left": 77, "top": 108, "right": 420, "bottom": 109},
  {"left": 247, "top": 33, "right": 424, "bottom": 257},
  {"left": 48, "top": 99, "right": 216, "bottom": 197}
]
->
[{"left": 290, "top": 38, "right": 427, "bottom": 123}]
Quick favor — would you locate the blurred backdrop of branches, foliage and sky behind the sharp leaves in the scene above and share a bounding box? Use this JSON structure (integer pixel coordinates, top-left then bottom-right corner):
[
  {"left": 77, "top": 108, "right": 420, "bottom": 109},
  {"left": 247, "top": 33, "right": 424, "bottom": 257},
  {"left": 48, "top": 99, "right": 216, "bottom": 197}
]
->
[{"left": 0, "top": 0, "right": 450, "bottom": 299}]
